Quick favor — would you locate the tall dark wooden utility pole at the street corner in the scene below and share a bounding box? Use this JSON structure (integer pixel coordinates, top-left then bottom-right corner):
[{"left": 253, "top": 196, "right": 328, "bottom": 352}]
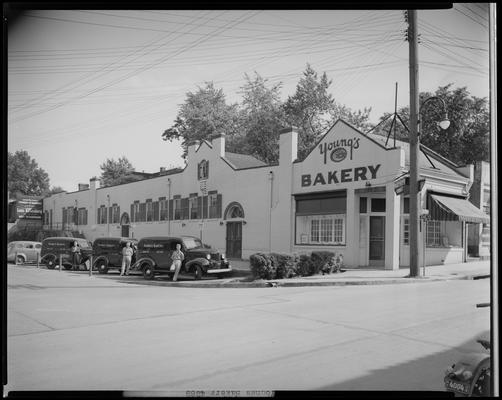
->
[{"left": 408, "top": 10, "right": 420, "bottom": 277}]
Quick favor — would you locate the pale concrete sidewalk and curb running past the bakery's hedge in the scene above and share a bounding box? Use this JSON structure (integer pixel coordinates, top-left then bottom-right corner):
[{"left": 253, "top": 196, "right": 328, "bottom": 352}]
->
[{"left": 173, "top": 260, "right": 491, "bottom": 287}]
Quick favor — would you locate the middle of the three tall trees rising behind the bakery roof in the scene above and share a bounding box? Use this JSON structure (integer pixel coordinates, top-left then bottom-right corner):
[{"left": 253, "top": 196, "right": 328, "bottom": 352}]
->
[{"left": 231, "top": 72, "right": 285, "bottom": 163}]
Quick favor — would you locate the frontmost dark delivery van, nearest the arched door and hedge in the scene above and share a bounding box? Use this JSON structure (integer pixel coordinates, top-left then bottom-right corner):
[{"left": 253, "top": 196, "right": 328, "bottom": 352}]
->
[{"left": 132, "top": 236, "right": 232, "bottom": 279}]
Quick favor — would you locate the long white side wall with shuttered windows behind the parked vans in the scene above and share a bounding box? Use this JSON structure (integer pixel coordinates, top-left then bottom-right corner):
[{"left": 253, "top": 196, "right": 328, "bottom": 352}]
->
[{"left": 44, "top": 137, "right": 277, "bottom": 258}]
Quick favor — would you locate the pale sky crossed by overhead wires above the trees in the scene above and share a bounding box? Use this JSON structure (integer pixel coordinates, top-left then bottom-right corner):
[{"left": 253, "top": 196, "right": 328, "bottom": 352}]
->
[{"left": 7, "top": 3, "right": 489, "bottom": 192}]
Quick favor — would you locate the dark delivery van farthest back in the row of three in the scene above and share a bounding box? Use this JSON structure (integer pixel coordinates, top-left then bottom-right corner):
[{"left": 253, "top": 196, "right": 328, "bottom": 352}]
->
[{"left": 40, "top": 237, "right": 92, "bottom": 269}]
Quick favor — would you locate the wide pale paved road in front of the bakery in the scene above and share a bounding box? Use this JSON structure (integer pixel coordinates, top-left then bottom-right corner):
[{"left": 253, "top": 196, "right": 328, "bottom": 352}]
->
[{"left": 4, "top": 265, "right": 490, "bottom": 395}]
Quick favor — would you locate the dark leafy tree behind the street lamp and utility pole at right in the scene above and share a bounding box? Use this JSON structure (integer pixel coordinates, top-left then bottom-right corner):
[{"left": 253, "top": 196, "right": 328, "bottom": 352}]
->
[{"left": 375, "top": 83, "right": 490, "bottom": 164}]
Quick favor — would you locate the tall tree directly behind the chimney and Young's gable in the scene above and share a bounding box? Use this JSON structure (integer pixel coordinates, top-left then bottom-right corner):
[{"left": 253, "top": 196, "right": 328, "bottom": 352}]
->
[{"left": 284, "top": 64, "right": 371, "bottom": 159}]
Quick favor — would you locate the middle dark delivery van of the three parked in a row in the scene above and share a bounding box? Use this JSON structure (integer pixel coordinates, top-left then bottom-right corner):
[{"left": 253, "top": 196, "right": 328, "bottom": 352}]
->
[{"left": 92, "top": 237, "right": 138, "bottom": 274}]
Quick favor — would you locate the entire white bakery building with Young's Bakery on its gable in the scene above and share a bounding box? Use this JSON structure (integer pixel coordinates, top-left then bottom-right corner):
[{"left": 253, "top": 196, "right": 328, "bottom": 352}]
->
[{"left": 43, "top": 120, "right": 489, "bottom": 269}]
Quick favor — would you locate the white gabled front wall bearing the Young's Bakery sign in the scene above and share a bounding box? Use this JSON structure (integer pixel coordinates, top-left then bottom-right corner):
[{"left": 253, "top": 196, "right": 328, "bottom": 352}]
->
[{"left": 293, "top": 120, "right": 404, "bottom": 269}]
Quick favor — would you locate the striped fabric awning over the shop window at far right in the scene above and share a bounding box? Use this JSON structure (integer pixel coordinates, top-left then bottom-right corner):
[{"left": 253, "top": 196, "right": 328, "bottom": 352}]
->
[{"left": 429, "top": 194, "right": 490, "bottom": 223}]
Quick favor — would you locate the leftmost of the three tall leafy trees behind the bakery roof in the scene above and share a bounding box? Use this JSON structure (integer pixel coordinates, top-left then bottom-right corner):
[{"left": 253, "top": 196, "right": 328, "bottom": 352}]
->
[{"left": 162, "top": 82, "right": 239, "bottom": 158}]
